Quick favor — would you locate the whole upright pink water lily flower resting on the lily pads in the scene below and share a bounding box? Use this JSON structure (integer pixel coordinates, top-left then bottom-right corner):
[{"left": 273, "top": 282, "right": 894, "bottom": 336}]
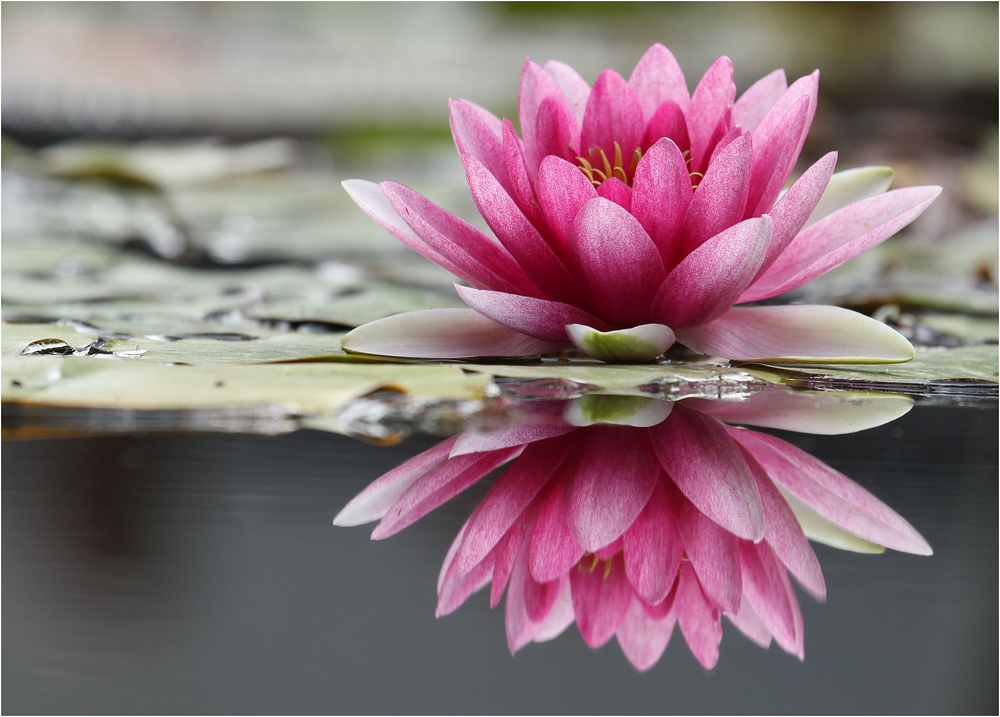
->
[{"left": 344, "top": 45, "right": 940, "bottom": 361}]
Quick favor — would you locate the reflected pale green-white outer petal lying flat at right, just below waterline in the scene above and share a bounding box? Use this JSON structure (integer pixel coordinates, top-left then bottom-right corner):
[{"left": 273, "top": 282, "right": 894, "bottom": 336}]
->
[{"left": 684, "top": 386, "right": 913, "bottom": 436}]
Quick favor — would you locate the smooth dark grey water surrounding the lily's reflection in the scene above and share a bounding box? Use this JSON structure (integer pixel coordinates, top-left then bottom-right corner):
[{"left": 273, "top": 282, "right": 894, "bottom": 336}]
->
[{"left": 2, "top": 405, "right": 998, "bottom": 713}]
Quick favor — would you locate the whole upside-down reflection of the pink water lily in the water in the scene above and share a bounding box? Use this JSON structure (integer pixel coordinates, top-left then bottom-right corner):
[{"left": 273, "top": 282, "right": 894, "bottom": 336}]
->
[{"left": 335, "top": 394, "right": 930, "bottom": 669}]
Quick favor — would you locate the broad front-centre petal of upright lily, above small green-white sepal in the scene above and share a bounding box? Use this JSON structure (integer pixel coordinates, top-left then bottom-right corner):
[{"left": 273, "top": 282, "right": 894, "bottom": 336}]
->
[{"left": 573, "top": 197, "right": 666, "bottom": 328}]
